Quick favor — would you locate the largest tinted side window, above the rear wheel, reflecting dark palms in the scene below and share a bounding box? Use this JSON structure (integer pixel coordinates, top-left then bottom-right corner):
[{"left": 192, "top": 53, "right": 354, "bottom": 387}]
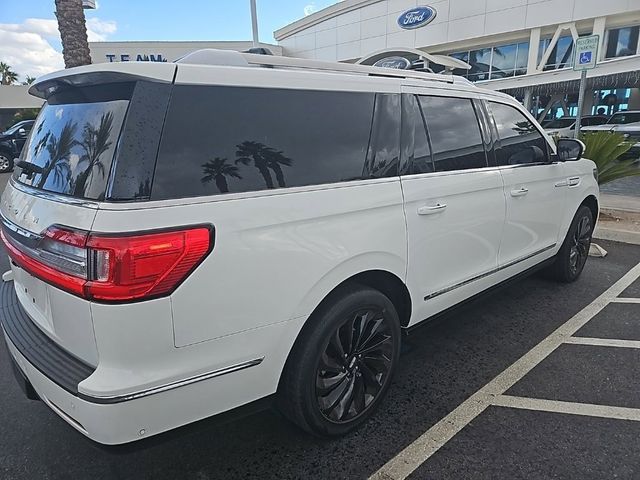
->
[{"left": 151, "top": 85, "right": 392, "bottom": 199}]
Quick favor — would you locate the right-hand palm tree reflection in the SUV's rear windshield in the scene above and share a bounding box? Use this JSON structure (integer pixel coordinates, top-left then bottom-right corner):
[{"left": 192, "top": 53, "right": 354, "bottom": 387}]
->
[{"left": 73, "top": 112, "right": 113, "bottom": 196}]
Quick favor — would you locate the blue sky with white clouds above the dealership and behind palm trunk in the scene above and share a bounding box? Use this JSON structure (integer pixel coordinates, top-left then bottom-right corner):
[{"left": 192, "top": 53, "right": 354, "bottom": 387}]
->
[{"left": 0, "top": 0, "right": 337, "bottom": 81}]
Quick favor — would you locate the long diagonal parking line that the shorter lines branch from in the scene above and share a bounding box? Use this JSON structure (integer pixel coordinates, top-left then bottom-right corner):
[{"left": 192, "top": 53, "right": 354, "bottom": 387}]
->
[{"left": 370, "top": 263, "right": 640, "bottom": 480}]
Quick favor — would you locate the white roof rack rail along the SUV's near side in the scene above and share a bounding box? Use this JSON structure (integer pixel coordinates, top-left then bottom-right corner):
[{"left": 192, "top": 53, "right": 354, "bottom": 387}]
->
[{"left": 176, "top": 49, "right": 464, "bottom": 85}]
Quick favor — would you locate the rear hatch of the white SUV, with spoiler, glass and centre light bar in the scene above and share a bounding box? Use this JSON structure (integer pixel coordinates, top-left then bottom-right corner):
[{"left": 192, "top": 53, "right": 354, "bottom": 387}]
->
[{"left": 0, "top": 64, "right": 175, "bottom": 366}]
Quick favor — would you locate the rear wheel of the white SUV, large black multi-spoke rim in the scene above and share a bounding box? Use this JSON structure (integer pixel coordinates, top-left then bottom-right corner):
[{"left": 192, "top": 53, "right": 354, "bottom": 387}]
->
[{"left": 277, "top": 285, "right": 401, "bottom": 436}]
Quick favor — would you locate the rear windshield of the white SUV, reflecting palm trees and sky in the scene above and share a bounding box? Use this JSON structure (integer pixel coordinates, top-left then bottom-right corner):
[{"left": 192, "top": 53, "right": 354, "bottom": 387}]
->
[{"left": 14, "top": 84, "right": 133, "bottom": 200}]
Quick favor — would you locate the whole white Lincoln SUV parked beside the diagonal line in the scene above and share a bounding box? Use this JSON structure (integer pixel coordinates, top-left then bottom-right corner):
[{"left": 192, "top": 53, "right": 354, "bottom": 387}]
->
[{"left": 1, "top": 51, "right": 598, "bottom": 444}]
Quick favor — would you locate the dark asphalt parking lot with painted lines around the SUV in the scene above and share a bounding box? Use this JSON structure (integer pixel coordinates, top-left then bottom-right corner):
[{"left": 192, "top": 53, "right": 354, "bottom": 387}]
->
[{"left": 0, "top": 172, "right": 640, "bottom": 480}]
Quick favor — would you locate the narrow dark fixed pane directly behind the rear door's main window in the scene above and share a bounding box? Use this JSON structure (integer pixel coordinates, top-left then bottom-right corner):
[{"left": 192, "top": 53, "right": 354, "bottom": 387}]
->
[{"left": 402, "top": 94, "right": 433, "bottom": 174}]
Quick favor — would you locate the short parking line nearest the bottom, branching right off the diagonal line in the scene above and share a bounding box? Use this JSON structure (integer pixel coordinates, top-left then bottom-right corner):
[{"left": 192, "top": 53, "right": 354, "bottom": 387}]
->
[{"left": 492, "top": 395, "right": 640, "bottom": 422}]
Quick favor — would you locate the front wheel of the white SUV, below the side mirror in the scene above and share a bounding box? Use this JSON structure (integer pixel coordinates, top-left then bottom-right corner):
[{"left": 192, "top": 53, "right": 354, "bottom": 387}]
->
[{"left": 547, "top": 205, "right": 594, "bottom": 283}]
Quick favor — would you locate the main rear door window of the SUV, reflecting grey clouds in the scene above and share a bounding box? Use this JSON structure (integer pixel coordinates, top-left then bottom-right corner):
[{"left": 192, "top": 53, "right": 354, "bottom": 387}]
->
[{"left": 420, "top": 96, "right": 487, "bottom": 172}]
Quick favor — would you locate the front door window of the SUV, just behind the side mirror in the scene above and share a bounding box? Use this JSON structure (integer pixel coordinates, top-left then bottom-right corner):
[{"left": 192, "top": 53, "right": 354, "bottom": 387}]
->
[{"left": 489, "top": 102, "right": 549, "bottom": 165}]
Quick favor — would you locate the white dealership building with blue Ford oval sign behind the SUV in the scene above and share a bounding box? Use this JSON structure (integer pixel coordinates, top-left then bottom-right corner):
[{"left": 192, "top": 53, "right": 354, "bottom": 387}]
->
[{"left": 1, "top": 0, "right": 640, "bottom": 124}]
